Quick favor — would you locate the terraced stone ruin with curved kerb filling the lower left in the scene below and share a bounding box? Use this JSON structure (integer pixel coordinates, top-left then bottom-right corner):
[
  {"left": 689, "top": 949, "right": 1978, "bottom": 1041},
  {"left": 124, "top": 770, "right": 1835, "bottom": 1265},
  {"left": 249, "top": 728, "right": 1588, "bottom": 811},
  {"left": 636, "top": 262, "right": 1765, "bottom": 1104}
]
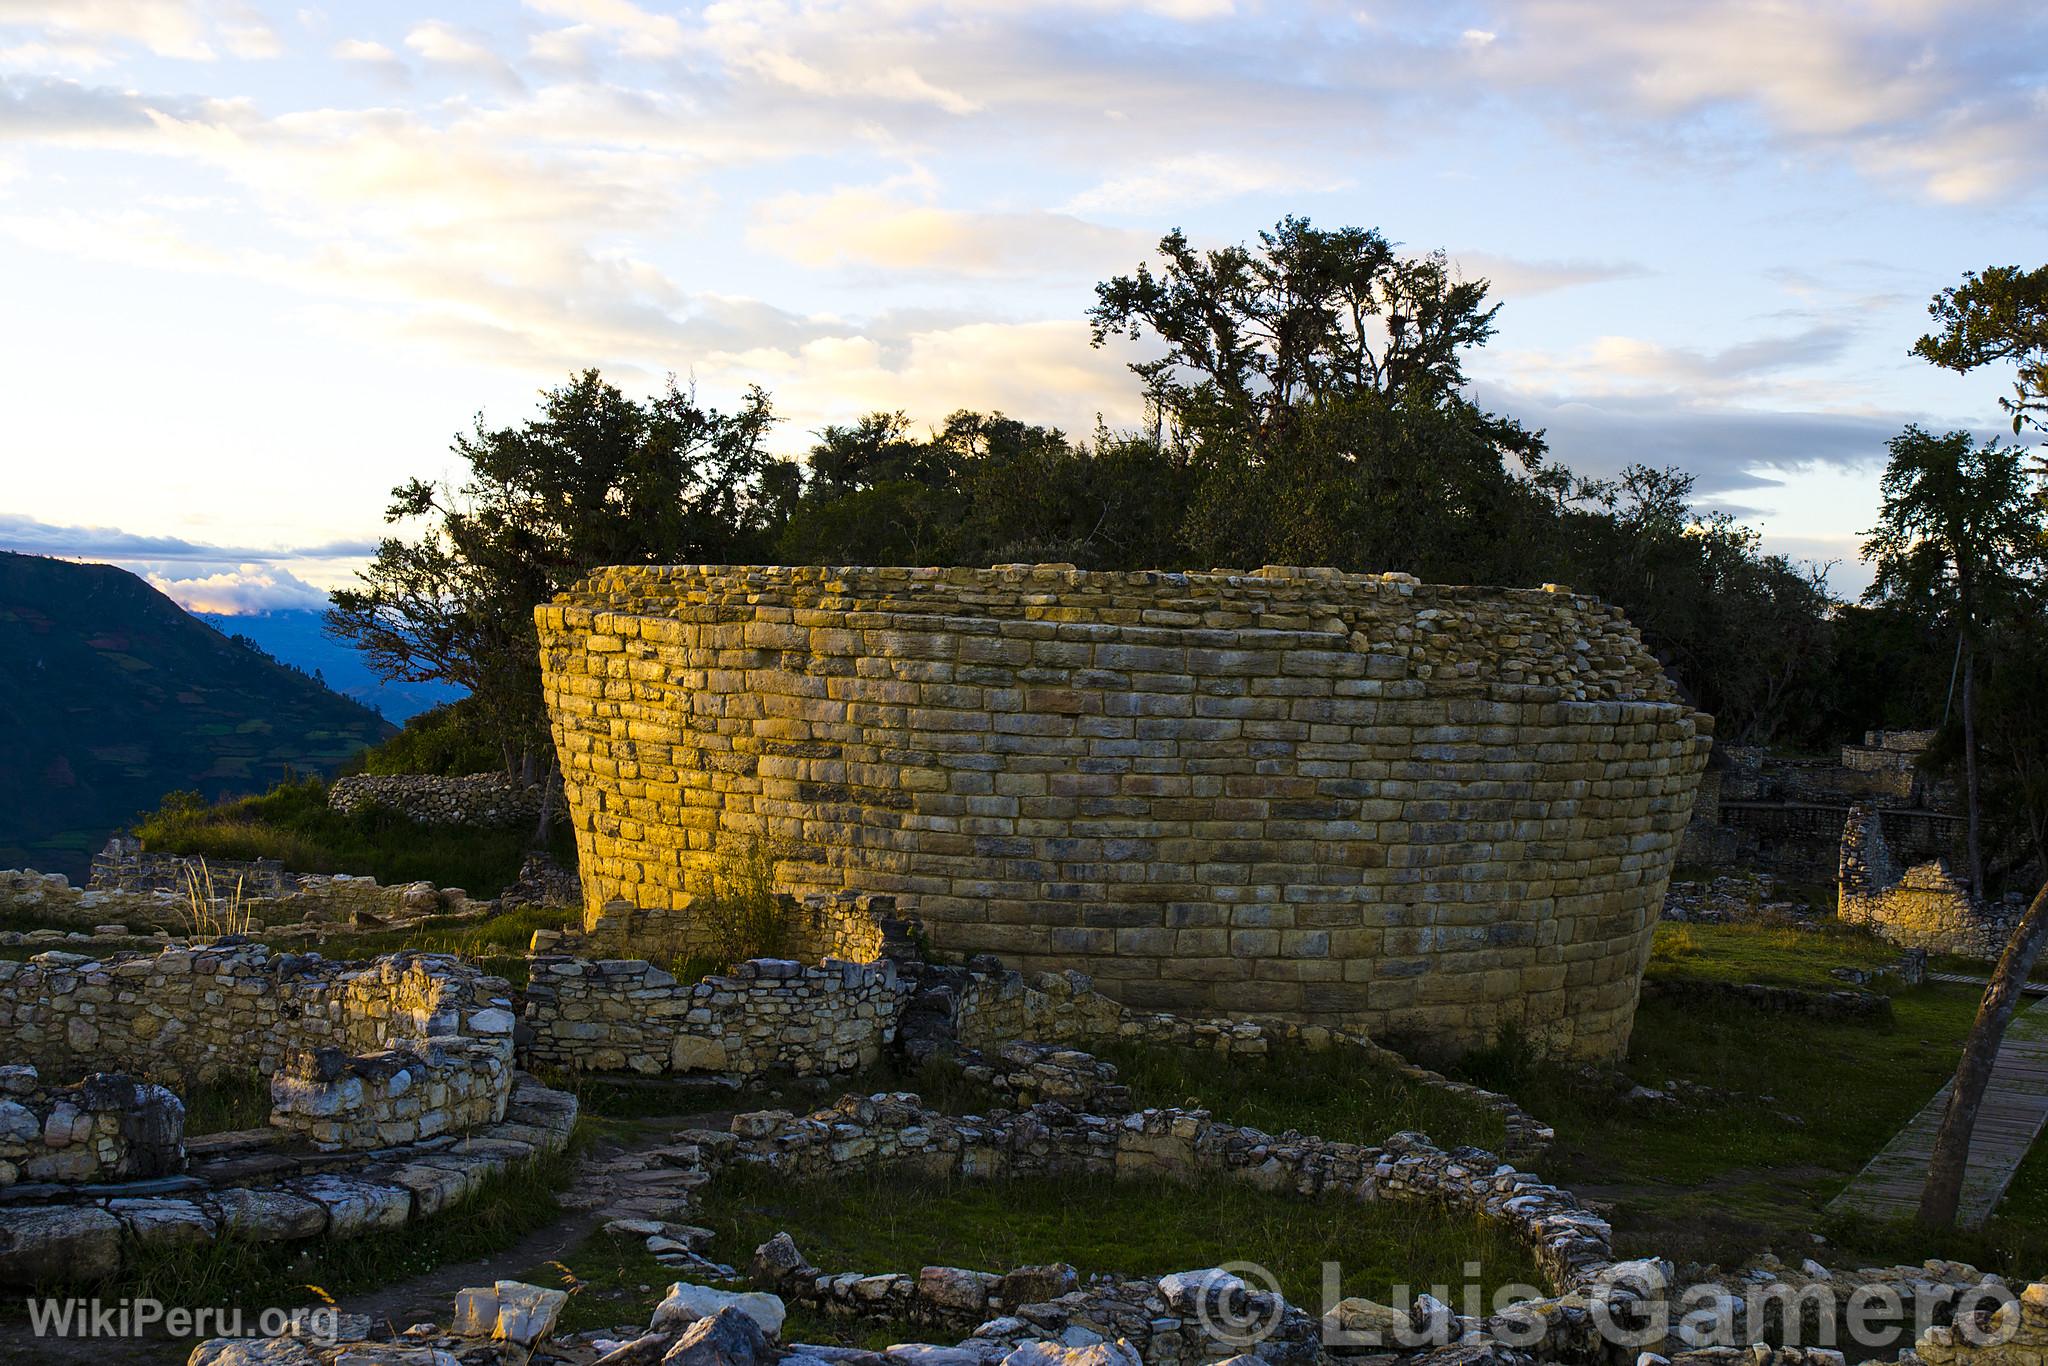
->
[{"left": 0, "top": 938, "right": 575, "bottom": 1286}]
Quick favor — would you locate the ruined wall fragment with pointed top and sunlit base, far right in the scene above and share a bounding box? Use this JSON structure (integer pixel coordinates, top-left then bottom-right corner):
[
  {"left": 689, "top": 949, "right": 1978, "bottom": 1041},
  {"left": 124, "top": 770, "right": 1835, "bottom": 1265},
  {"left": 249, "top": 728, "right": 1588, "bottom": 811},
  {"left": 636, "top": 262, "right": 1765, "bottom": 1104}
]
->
[{"left": 1835, "top": 805, "right": 2019, "bottom": 961}]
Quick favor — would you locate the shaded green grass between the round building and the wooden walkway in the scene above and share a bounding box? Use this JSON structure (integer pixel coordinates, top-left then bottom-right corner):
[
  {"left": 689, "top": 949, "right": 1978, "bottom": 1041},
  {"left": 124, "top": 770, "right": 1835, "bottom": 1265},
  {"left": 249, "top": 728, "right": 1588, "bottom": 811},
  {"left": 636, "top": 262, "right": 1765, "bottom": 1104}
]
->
[{"left": 1460, "top": 926, "right": 2048, "bottom": 1274}]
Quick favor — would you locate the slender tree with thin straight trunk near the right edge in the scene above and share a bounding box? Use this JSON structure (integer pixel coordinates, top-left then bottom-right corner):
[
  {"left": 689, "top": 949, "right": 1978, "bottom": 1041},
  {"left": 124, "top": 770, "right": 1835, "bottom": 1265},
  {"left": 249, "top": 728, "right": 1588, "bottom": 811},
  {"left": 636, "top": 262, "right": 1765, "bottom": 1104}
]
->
[{"left": 1864, "top": 426, "right": 2042, "bottom": 895}]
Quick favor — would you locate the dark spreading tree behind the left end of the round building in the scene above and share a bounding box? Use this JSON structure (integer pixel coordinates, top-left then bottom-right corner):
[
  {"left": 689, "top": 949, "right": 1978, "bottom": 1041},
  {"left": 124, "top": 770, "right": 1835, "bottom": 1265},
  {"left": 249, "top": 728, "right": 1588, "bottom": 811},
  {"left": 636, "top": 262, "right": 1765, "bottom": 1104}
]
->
[{"left": 328, "top": 371, "right": 793, "bottom": 829}]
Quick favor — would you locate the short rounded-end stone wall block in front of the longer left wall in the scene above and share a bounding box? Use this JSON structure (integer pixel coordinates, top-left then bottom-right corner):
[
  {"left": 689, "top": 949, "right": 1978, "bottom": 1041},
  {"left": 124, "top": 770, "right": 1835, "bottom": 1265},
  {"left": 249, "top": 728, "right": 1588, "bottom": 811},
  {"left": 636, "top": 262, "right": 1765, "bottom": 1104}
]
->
[{"left": 270, "top": 1038, "right": 512, "bottom": 1151}]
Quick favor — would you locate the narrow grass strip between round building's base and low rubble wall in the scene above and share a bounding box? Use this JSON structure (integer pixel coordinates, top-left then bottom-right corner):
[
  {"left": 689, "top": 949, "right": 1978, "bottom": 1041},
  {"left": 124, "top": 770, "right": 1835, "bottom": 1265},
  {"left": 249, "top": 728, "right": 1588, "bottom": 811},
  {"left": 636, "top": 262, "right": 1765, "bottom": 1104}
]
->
[{"left": 1096, "top": 1044, "right": 1507, "bottom": 1153}]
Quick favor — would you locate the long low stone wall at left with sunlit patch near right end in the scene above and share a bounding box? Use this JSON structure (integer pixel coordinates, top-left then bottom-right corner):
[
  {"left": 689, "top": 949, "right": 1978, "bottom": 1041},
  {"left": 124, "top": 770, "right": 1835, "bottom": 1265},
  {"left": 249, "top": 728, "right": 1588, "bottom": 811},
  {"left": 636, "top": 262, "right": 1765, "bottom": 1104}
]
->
[{"left": 0, "top": 942, "right": 514, "bottom": 1077}]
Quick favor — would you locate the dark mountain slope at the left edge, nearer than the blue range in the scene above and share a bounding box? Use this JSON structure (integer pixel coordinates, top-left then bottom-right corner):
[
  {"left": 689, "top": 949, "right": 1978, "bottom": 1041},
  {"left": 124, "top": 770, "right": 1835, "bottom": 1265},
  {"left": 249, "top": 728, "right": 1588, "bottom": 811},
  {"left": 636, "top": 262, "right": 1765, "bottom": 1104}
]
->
[{"left": 0, "top": 553, "right": 391, "bottom": 879}]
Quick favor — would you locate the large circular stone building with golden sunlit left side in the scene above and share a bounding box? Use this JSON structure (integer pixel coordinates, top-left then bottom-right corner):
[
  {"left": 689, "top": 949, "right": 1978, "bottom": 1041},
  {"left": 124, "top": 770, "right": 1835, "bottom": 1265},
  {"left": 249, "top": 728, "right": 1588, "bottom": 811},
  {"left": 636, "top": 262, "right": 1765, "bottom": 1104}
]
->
[{"left": 537, "top": 565, "right": 1712, "bottom": 1057}]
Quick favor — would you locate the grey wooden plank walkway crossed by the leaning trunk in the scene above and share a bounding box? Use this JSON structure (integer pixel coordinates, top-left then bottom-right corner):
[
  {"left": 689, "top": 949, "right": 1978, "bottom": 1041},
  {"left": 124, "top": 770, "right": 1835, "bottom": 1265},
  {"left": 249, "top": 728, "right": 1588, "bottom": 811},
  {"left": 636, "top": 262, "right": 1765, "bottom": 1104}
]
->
[{"left": 1829, "top": 999, "right": 2048, "bottom": 1229}]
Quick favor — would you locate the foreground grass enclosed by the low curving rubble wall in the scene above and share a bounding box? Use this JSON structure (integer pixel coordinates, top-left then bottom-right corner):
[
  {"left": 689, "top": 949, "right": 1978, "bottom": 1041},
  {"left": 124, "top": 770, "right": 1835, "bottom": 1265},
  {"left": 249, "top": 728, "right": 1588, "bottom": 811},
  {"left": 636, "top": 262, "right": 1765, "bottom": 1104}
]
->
[{"left": 548, "top": 1167, "right": 1542, "bottom": 1346}]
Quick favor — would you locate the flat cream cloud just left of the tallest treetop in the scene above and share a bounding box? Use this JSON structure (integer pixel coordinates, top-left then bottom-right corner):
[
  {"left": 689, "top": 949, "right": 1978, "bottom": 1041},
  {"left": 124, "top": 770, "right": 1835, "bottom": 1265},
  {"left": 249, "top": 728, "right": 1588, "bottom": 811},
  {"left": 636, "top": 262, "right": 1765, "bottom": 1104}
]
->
[{"left": 748, "top": 188, "right": 1147, "bottom": 274}]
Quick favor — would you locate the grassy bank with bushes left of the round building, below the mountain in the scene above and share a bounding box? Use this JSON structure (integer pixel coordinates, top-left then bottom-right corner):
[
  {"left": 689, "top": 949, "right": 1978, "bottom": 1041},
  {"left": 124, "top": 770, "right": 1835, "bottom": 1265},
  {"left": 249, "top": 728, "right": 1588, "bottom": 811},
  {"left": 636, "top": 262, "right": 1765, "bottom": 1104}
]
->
[{"left": 135, "top": 778, "right": 575, "bottom": 897}]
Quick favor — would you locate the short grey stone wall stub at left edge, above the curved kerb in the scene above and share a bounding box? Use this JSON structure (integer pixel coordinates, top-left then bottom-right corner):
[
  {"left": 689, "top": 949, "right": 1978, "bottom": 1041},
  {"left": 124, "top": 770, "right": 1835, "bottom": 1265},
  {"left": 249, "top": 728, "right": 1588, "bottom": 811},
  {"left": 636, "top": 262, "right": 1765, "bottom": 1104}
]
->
[{"left": 0, "top": 1063, "right": 184, "bottom": 1190}]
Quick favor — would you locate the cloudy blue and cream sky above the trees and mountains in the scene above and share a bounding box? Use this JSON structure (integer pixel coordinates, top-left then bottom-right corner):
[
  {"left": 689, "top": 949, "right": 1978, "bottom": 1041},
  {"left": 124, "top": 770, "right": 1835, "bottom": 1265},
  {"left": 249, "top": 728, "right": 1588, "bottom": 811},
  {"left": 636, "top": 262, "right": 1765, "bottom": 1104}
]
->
[{"left": 0, "top": 0, "right": 2048, "bottom": 610}]
